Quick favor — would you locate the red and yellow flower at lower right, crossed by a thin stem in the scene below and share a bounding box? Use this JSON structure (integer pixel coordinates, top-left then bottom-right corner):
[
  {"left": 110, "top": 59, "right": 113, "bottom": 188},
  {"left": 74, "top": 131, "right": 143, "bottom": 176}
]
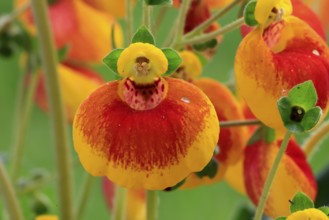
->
[{"left": 243, "top": 140, "right": 317, "bottom": 218}]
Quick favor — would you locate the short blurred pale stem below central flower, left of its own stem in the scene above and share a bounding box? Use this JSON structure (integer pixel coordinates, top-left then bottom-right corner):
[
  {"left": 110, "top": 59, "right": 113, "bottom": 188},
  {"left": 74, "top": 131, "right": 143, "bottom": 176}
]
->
[{"left": 113, "top": 186, "right": 127, "bottom": 220}]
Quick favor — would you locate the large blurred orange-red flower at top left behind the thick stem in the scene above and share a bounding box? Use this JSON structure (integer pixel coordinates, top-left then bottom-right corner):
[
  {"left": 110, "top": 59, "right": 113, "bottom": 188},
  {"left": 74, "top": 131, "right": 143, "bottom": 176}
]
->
[{"left": 16, "top": 0, "right": 123, "bottom": 63}]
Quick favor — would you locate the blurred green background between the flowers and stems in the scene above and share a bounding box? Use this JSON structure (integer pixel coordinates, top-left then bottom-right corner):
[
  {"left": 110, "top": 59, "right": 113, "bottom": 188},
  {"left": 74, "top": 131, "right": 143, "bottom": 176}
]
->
[{"left": 0, "top": 0, "right": 329, "bottom": 220}]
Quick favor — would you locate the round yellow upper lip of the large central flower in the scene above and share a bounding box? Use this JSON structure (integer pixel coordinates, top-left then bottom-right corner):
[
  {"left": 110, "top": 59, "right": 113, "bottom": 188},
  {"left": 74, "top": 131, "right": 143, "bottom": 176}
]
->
[{"left": 118, "top": 43, "right": 168, "bottom": 84}]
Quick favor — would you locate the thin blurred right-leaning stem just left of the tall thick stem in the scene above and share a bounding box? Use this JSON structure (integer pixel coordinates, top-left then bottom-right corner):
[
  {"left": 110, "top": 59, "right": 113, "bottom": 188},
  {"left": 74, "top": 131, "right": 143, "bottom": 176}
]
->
[{"left": 10, "top": 68, "right": 39, "bottom": 182}]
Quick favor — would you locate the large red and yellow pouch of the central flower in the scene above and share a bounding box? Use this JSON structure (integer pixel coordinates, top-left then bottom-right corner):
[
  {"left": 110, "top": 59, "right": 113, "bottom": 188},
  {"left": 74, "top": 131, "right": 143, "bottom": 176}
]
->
[{"left": 73, "top": 78, "right": 219, "bottom": 189}]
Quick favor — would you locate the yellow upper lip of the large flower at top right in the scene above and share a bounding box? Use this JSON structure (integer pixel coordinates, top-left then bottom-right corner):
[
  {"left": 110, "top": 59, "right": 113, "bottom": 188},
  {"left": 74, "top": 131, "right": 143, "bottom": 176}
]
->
[{"left": 255, "top": 0, "right": 292, "bottom": 27}]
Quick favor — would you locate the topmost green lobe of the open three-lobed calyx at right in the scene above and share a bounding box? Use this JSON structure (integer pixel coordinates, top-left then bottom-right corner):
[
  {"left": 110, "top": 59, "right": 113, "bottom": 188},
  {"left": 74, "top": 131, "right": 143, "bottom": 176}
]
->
[{"left": 288, "top": 80, "right": 318, "bottom": 111}]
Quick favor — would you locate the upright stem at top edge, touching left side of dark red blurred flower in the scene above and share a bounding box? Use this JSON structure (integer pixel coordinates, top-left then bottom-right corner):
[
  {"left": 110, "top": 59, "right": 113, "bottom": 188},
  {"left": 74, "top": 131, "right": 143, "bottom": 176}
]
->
[{"left": 172, "top": 0, "right": 192, "bottom": 48}]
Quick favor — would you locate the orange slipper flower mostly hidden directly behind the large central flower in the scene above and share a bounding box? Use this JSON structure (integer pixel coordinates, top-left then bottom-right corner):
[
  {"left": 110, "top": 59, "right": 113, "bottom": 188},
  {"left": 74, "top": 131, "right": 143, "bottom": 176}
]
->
[{"left": 173, "top": 51, "right": 248, "bottom": 188}]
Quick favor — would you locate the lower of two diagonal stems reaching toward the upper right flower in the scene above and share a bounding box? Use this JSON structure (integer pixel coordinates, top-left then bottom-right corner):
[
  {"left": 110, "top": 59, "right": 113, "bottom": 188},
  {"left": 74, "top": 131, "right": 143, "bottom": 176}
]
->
[{"left": 178, "top": 17, "right": 244, "bottom": 47}]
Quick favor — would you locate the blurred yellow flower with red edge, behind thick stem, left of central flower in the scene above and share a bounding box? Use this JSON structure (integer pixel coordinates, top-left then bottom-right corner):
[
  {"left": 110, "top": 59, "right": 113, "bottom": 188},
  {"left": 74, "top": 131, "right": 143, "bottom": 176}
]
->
[{"left": 35, "top": 64, "right": 104, "bottom": 122}]
